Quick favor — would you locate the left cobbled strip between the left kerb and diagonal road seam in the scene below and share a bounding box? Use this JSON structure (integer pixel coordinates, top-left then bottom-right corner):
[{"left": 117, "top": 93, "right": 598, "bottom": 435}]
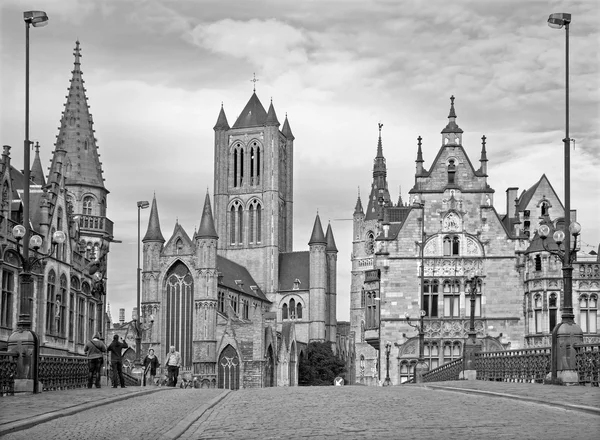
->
[{"left": 0, "top": 388, "right": 226, "bottom": 440}]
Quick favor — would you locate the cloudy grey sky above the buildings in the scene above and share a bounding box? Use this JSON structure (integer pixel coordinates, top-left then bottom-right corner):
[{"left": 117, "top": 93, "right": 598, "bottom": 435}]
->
[{"left": 0, "top": 0, "right": 600, "bottom": 321}]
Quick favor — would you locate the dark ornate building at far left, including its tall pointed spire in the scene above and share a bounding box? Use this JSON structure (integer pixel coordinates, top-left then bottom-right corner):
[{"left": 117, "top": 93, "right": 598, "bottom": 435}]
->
[{"left": 0, "top": 41, "right": 113, "bottom": 354}]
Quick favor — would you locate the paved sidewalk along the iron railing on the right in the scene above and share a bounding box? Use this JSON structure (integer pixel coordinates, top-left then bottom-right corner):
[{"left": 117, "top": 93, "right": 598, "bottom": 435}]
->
[{"left": 408, "top": 380, "right": 600, "bottom": 416}]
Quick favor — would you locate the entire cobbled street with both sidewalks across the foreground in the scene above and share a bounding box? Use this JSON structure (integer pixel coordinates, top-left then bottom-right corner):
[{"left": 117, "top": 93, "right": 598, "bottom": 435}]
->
[{"left": 0, "top": 381, "right": 600, "bottom": 440}]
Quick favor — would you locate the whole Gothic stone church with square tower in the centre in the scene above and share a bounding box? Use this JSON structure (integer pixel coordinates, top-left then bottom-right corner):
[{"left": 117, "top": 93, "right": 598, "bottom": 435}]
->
[{"left": 141, "top": 89, "right": 338, "bottom": 389}]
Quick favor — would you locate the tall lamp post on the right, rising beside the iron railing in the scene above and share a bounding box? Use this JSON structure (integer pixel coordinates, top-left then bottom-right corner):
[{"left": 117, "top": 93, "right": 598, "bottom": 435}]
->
[{"left": 540, "top": 13, "right": 583, "bottom": 383}]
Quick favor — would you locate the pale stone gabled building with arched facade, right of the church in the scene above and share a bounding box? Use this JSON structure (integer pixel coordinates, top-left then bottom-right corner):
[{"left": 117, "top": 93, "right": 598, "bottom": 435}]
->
[{"left": 351, "top": 97, "right": 599, "bottom": 384}]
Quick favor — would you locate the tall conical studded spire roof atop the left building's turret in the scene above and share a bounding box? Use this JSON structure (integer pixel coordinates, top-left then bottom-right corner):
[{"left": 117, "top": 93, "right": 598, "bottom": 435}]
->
[{"left": 50, "top": 41, "right": 106, "bottom": 190}]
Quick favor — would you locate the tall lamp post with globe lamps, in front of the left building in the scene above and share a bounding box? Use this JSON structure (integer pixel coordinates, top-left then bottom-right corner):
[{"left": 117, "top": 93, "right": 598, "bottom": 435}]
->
[{"left": 8, "top": 11, "right": 49, "bottom": 393}]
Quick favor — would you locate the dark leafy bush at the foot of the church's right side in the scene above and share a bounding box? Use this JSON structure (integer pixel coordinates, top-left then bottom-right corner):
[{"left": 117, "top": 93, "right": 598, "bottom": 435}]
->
[{"left": 298, "top": 342, "right": 346, "bottom": 386}]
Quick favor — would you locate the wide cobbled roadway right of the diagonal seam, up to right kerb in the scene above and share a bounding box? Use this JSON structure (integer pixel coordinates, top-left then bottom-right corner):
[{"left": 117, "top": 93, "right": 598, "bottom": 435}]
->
[{"left": 180, "top": 386, "right": 600, "bottom": 440}]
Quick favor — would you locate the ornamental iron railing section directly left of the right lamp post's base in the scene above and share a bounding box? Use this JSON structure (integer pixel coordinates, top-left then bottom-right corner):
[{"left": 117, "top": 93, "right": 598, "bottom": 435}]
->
[{"left": 475, "top": 347, "right": 551, "bottom": 383}]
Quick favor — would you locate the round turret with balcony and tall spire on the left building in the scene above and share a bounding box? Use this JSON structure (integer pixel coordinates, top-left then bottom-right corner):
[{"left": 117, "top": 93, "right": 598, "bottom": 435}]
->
[{"left": 49, "top": 41, "right": 113, "bottom": 265}]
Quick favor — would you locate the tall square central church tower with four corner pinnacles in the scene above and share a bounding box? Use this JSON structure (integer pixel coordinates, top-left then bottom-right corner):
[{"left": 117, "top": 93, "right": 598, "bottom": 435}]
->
[{"left": 214, "top": 92, "right": 294, "bottom": 301}]
